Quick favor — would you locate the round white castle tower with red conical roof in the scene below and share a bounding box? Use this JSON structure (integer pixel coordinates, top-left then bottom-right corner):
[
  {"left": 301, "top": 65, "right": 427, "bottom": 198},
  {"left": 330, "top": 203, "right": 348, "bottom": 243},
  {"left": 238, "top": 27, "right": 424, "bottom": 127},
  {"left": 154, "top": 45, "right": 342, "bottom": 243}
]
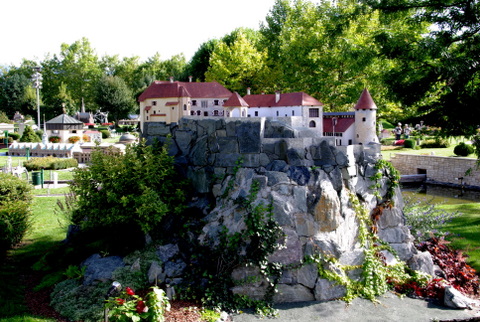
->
[{"left": 354, "top": 88, "right": 379, "bottom": 144}]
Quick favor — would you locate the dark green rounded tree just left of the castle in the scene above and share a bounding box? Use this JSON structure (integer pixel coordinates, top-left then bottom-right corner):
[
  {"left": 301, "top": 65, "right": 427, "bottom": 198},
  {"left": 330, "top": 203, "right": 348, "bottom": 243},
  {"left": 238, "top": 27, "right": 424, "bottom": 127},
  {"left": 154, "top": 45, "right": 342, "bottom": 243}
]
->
[{"left": 95, "top": 76, "right": 134, "bottom": 124}]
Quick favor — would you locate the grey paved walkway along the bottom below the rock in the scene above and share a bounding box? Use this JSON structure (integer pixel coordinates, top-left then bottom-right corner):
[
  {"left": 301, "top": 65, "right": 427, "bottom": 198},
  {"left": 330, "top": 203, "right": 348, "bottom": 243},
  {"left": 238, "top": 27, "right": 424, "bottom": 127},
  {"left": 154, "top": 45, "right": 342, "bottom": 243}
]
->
[{"left": 233, "top": 293, "right": 480, "bottom": 322}]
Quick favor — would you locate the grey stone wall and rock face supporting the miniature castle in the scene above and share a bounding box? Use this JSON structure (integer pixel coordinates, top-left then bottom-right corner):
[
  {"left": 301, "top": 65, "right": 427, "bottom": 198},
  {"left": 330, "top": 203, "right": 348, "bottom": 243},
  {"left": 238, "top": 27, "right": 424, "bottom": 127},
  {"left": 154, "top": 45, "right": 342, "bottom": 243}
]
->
[{"left": 143, "top": 118, "right": 433, "bottom": 302}]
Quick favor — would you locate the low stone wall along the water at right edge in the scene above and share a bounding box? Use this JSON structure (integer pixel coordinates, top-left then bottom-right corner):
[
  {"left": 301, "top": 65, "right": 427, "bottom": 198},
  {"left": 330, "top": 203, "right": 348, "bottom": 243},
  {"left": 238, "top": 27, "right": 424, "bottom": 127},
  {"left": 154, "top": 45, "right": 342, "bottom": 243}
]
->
[{"left": 391, "top": 153, "right": 480, "bottom": 187}]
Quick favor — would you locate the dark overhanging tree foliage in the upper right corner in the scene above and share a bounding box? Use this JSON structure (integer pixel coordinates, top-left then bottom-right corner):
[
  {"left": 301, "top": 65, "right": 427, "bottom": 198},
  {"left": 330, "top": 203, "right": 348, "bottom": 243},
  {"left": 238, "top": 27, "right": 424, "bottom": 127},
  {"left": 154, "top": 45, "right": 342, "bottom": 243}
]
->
[{"left": 364, "top": 0, "right": 480, "bottom": 136}]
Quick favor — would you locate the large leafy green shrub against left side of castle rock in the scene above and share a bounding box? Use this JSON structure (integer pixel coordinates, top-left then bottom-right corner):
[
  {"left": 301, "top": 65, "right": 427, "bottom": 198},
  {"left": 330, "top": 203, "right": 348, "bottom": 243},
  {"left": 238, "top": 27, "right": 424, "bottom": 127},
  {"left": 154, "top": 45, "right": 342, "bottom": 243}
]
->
[{"left": 71, "top": 142, "right": 185, "bottom": 233}]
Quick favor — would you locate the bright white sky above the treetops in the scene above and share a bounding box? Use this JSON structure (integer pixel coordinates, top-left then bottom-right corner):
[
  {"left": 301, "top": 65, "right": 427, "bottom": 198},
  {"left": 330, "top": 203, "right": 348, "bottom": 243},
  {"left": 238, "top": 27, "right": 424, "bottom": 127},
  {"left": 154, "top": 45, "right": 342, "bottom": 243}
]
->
[{"left": 0, "top": 0, "right": 275, "bottom": 66}]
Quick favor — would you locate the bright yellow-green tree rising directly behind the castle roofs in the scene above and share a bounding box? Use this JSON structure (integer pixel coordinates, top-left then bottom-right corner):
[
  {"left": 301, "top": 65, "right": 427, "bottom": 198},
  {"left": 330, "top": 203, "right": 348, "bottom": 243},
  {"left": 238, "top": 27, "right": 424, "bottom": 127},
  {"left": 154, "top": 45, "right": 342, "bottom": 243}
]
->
[{"left": 205, "top": 31, "right": 266, "bottom": 94}]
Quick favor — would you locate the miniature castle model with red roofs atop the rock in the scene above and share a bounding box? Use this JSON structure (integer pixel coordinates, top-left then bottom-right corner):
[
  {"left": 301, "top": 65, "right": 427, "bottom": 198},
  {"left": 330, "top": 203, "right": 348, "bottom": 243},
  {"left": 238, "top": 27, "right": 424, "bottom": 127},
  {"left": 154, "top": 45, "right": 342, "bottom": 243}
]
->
[{"left": 138, "top": 78, "right": 379, "bottom": 145}]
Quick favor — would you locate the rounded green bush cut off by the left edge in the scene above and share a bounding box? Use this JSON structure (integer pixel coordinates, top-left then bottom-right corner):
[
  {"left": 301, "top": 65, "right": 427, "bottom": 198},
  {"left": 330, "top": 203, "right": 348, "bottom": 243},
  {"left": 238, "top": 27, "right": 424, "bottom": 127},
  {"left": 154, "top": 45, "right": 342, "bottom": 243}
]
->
[{"left": 0, "top": 173, "right": 32, "bottom": 255}]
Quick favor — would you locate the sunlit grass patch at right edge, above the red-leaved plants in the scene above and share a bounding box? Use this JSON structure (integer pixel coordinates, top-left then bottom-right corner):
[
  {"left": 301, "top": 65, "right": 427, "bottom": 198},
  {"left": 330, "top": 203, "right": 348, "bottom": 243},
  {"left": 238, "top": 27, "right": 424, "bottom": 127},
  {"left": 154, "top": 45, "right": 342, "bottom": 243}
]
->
[{"left": 438, "top": 203, "right": 480, "bottom": 272}]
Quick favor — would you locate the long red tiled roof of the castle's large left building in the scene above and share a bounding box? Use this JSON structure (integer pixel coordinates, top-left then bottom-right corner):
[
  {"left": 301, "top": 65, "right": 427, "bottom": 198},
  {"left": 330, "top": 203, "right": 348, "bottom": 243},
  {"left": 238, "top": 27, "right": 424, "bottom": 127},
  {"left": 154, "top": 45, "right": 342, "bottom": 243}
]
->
[{"left": 138, "top": 81, "right": 232, "bottom": 102}]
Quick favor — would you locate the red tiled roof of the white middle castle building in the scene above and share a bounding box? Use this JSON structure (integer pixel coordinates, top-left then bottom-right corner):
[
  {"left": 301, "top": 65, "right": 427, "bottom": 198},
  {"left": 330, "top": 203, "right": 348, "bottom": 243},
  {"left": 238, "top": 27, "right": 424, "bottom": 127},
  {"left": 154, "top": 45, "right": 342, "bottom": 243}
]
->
[{"left": 243, "top": 92, "right": 323, "bottom": 107}]
